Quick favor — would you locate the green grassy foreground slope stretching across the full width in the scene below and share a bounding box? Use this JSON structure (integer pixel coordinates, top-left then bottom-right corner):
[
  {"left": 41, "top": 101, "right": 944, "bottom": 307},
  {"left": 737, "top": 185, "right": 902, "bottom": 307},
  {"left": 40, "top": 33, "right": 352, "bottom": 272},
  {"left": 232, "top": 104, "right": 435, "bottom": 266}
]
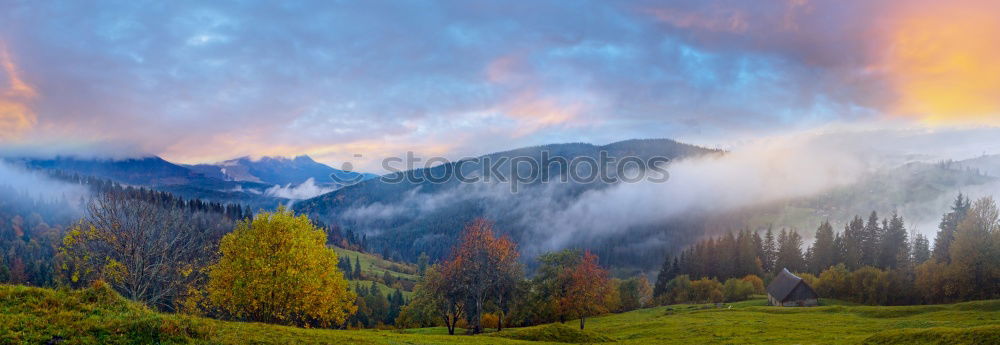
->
[{"left": 0, "top": 285, "right": 1000, "bottom": 344}]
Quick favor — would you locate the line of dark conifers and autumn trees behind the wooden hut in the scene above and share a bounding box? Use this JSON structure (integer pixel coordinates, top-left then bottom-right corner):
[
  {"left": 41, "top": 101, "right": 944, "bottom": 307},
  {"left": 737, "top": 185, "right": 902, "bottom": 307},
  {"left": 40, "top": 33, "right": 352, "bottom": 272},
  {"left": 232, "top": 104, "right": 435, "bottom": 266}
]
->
[{"left": 654, "top": 194, "right": 1000, "bottom": 304}]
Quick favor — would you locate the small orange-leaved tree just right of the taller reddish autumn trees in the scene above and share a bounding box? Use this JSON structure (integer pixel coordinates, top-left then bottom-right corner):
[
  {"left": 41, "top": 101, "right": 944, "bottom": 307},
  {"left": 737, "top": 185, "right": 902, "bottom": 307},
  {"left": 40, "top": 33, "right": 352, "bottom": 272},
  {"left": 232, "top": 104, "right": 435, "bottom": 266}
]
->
[{"left": 557, "top": 251, "right": 615, "bottom": 329}]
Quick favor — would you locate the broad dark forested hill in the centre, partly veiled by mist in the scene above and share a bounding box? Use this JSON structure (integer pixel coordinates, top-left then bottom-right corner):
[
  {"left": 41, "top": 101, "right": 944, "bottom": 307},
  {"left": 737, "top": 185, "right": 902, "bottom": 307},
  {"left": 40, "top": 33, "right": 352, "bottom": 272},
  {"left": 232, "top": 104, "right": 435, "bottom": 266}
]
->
[{"left": 295, "top": 139, "right": 721, "bottom": 262}]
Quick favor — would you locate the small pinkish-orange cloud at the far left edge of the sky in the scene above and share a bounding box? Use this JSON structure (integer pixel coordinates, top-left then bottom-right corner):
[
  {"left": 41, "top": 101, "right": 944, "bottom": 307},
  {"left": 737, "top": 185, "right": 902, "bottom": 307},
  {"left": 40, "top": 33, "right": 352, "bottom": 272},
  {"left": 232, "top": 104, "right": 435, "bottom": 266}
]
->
[{"left": 0, "top": 42, "right": 37, "bottom": 140}]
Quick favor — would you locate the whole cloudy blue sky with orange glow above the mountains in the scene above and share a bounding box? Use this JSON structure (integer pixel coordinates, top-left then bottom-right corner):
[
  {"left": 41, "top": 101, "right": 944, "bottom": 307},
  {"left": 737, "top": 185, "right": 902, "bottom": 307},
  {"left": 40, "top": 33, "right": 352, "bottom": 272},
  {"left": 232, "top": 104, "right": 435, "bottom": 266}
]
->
[{"left": 0, "top": 0, "right": 1000, "bottom": 169}]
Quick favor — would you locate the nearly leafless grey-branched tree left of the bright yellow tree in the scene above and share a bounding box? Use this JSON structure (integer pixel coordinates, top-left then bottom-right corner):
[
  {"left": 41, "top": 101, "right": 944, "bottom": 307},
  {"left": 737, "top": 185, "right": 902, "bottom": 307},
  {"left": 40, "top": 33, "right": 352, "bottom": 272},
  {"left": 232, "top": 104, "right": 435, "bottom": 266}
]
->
[{"left": 59, "top": 193, "right": 212, "bottom": 310}]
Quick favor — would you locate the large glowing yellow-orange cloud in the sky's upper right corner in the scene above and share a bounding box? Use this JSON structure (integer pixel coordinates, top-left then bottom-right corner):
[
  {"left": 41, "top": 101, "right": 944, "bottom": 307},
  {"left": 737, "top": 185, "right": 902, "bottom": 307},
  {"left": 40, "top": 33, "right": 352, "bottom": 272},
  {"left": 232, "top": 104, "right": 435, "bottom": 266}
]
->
[{"left": 882, "top": 0, "right": 1000, "bottom": 124}]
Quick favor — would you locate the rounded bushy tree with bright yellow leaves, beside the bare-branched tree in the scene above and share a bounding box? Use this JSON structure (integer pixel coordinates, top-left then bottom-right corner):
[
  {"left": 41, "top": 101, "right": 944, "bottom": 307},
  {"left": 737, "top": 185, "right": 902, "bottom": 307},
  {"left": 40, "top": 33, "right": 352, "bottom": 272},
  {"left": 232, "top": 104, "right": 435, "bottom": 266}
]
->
[{"left": 207, "top": 208, "right": 357, "bottom": 327}]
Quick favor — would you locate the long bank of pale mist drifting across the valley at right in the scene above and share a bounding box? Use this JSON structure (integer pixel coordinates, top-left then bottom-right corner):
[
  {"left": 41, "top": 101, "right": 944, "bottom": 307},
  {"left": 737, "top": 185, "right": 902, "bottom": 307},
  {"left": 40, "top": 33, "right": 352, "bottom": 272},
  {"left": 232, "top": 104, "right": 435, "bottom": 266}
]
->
[{"left": 341, "top": 123, "right": 1000, "bottom": 254}]
